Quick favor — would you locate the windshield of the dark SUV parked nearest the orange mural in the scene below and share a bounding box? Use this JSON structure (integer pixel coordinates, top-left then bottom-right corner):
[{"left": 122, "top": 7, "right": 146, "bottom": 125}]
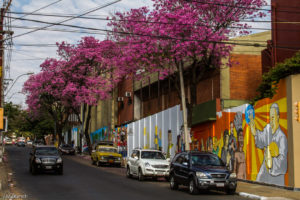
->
[{"left": 191, "top": 155, "right": 224, "bottom": 166}]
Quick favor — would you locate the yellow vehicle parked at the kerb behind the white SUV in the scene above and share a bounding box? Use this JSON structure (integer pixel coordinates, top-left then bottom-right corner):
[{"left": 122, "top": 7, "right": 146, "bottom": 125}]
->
[{"left": 91, "top": 145, "right": 122, "bottom": 167}]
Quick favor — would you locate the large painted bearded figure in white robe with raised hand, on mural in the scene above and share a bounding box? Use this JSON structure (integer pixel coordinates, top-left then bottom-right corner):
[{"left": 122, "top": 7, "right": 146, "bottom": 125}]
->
[{"left": 249, "top": 103, "right": 288, "bottom": 185}]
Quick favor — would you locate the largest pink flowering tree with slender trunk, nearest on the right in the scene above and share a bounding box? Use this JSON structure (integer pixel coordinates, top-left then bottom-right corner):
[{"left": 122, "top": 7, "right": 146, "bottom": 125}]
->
[{"left": 109, "top": 0, "right": 266, "bottom": 150}]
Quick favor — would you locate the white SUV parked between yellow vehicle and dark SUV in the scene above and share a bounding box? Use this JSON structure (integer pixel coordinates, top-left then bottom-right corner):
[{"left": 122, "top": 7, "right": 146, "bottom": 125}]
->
[{"left": 126, "top": 149, "right": 170, "bottom": 181}]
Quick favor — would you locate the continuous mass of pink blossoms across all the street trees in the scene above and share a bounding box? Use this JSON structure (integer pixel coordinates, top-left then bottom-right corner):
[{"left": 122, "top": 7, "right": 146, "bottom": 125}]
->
[{"left": 24, "top": 0, "right": 266, "bottom": 115}]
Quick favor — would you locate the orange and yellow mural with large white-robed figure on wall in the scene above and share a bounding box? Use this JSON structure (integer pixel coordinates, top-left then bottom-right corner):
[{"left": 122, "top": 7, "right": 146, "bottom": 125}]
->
[{"left": 191, "top": 80, "right": 288, "bottom": 186}]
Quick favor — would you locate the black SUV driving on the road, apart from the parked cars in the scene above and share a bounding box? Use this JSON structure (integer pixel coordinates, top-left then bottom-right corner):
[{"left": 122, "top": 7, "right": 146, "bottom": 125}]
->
[{"left": 29, "top": 146, "right": 63, "bottom": 175}]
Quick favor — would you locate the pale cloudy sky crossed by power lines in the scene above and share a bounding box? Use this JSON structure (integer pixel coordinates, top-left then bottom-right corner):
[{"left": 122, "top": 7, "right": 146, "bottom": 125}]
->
[{"left": 1, "top": 0, "right": 270, "bottom": 108}]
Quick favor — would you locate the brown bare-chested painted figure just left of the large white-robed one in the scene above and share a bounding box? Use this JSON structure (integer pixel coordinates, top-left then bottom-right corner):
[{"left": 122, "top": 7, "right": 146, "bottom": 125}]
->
[{"left": 234, "top": 128, "right": 246, "bottom": 179}]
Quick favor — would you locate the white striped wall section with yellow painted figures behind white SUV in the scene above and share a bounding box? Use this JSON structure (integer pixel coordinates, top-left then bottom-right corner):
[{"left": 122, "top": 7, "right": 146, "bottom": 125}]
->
[{"left": 127, "top": 105, "right": 182, "bottom": 158}]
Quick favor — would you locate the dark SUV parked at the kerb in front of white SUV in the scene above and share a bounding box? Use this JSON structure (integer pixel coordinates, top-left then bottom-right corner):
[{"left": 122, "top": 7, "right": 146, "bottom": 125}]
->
[{"left": 170, "top": 151, "right": 237, "bottom": 194}]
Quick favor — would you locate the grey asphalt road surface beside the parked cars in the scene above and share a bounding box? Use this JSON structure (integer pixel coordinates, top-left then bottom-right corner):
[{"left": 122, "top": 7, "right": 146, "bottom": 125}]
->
[{"left": 6, "top": 146, "right": 245, "bottom": 200}]
